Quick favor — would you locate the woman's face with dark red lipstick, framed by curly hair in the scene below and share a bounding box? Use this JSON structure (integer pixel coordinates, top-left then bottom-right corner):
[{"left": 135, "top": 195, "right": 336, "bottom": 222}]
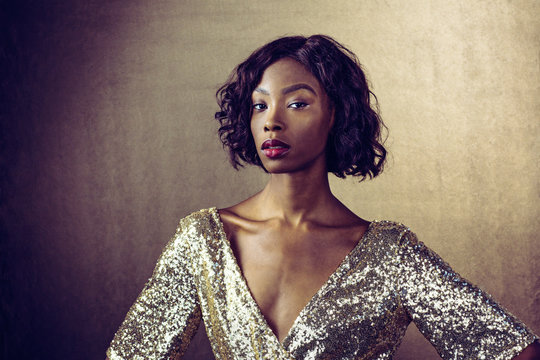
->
[{"left": 251, "top": 58, "right": 334, "bottom": 173}]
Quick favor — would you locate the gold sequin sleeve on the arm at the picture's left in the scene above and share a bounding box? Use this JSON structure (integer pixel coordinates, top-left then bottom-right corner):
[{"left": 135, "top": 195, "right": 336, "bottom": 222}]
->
[{"left": 107, "top": 221, "right": 201, "bottom": 360}]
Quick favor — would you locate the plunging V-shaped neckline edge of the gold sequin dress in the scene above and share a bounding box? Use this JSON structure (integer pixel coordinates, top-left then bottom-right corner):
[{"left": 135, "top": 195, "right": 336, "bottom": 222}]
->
[{"left": 210, "top": 207, "right": 375, "bottom": 352}]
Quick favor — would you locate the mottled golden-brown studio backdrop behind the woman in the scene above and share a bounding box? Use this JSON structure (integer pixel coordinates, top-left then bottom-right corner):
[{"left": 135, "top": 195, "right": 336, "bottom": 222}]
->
[{"left": 1, "top": 0, "right": 540, "bottom": 359}]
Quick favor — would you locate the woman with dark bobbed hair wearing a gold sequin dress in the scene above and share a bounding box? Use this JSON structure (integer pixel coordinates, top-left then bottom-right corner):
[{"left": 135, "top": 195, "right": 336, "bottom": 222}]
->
[{"left": 108, "top": 35, "right": 539, "bottom": 360}]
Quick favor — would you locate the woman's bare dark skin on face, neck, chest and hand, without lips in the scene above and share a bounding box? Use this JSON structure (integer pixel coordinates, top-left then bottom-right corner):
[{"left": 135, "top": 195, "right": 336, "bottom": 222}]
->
[{"left": 105, "top": 59, "right": 540, "bottom": 360}]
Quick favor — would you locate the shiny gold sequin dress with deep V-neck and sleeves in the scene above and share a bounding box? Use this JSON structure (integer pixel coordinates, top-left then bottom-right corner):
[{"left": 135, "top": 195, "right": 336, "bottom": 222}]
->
[{"left": 107, "top": 208, "right": 537, "bottom": 360}]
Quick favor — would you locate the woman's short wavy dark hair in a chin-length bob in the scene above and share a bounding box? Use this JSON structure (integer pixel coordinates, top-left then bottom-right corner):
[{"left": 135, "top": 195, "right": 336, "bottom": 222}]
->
[{"left": 215, "top": 35, "right": 386, "bottom": 181}]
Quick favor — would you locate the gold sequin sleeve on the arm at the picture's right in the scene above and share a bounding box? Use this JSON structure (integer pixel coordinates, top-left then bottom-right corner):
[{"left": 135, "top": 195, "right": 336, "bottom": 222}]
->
[{"left": 398, "top": 230, "right": 537, "bottom": 359}]
